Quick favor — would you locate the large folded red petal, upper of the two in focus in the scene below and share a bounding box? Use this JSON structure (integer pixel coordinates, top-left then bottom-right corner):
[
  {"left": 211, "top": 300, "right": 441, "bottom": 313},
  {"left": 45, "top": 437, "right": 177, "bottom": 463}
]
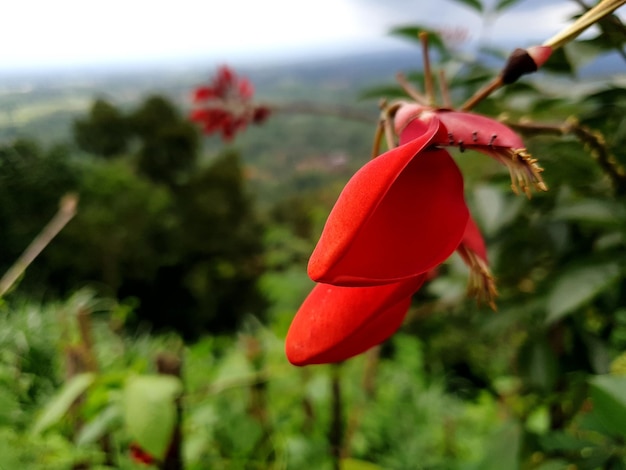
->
[{"left": 308, "top": 120, "right": 469, "bottom": 286}]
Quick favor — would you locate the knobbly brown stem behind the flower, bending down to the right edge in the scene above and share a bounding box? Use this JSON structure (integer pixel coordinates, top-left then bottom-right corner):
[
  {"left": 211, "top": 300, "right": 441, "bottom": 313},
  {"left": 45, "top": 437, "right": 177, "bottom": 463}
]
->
[{"left": 504, "top": 118, "right": 626, "bottom": 195}]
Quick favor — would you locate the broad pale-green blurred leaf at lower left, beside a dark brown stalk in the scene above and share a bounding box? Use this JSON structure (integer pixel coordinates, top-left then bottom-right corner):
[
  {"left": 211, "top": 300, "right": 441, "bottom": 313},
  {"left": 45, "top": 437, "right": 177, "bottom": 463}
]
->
[{"left": 123, "top": 375, "right": 182, "bottom": 459}]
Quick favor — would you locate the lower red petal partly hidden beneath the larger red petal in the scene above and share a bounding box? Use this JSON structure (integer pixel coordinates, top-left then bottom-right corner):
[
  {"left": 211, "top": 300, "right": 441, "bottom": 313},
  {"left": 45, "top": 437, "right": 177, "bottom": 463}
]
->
[{"left": 285, "top": 275, "right": 425, "bottom": 366}]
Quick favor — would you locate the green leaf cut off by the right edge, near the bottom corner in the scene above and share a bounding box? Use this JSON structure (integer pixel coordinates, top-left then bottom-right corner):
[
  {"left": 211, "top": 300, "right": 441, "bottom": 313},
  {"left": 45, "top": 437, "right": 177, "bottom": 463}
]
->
[{"left": 590, "top": 375, "right": 626, "bottom": 437}]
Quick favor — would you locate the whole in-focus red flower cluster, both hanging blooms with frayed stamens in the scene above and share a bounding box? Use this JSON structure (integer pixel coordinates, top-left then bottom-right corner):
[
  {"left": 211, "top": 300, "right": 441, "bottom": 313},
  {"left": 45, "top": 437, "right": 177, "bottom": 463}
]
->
[{"left": 286, "top": 90, "right": 546, "bottom": 365}]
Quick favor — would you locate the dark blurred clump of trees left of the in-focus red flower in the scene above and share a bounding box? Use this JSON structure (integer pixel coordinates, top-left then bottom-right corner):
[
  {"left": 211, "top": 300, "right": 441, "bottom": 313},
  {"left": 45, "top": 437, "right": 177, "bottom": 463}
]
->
[{"left": 0, "top": 96, "right": 265, "bottom": 338}]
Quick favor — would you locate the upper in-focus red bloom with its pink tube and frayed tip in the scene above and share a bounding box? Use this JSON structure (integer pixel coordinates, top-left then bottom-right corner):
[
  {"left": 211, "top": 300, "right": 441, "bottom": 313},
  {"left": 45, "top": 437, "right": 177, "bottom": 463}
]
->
[{"left": 308, "top": 104, "right": 546, "bottom": 286}]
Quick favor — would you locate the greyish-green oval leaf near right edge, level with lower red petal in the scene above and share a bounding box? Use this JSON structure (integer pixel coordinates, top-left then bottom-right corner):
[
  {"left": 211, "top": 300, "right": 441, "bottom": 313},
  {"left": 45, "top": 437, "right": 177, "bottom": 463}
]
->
[{"left": 546, "top": 262, "right": 620, "bottom": 323}]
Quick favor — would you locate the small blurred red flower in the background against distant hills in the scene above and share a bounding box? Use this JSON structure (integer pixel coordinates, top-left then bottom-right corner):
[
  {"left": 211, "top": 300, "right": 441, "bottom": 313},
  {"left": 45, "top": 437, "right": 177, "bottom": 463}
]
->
[{"left": 190, "top": 66, "right": 270, "bottom": 140}]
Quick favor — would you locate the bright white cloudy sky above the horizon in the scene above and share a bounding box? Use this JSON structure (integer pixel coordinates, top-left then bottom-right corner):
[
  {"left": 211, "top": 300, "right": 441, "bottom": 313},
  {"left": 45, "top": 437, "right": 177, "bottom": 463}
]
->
[{"left": 0, "top": 0, "right": 608, "bottom": 70}]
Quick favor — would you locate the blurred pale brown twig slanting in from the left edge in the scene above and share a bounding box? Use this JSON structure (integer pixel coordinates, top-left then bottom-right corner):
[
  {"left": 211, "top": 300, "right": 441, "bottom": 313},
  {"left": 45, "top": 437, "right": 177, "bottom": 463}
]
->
[{"left": 0, "top": 194, "right": 78, "bottom": 297}]
